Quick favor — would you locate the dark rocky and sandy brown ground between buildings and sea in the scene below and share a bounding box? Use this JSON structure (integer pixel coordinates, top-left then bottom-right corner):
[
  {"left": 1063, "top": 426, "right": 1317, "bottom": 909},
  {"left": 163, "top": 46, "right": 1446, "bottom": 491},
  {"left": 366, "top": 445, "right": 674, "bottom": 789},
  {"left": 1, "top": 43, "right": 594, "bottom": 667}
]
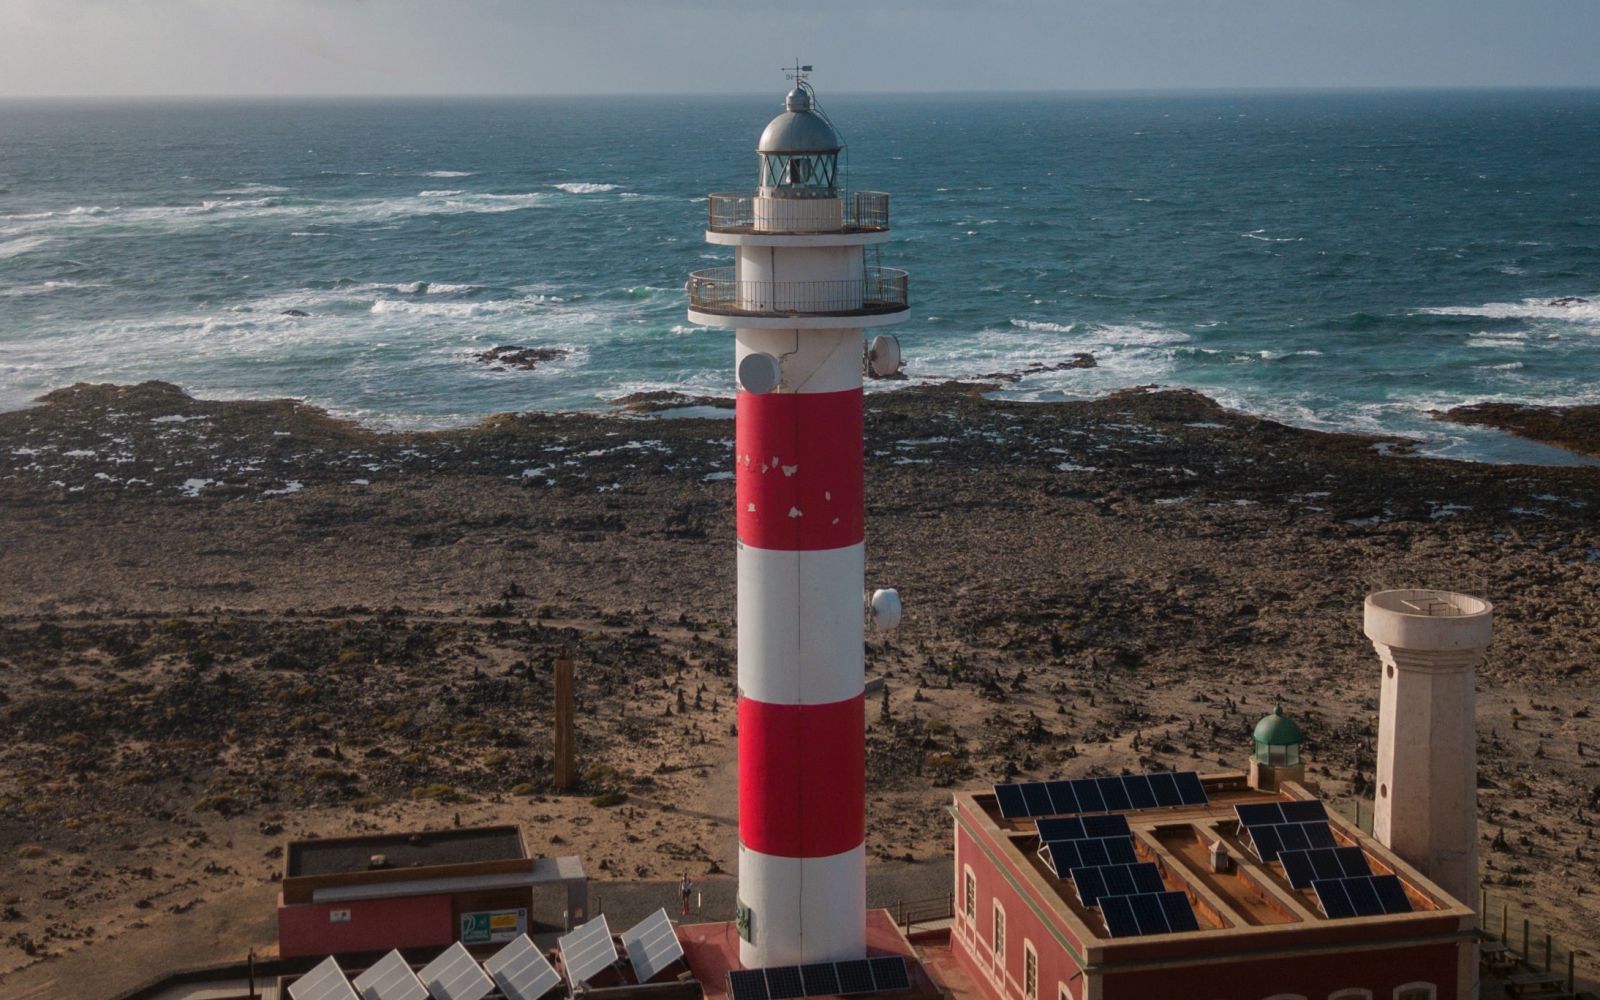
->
[{"left": 0, "top": 377, "right": 1600, "bottom": 997}]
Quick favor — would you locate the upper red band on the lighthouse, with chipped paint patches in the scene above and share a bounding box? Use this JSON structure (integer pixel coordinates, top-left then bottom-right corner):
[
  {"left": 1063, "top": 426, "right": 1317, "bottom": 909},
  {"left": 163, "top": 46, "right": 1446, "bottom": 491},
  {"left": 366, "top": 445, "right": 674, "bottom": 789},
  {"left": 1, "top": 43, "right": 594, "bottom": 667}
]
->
[{"left": 734, "top": 389, "right": 864, "bottom": 552}]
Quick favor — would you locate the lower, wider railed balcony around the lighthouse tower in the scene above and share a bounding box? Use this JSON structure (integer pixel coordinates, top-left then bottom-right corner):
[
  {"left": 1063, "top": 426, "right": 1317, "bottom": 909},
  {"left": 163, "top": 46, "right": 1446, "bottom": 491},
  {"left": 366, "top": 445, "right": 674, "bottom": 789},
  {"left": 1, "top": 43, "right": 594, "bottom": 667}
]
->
[{"left": 688, "top": 267, "right": 907, "bottom": 317}]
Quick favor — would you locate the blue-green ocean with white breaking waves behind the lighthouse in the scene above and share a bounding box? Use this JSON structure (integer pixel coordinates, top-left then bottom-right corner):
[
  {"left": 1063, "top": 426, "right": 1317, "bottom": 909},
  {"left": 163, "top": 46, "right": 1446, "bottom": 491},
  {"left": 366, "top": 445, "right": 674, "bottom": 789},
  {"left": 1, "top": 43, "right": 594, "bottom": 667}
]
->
[{"left": 0, "top": 89, "right": 1600, "bottom": 462}]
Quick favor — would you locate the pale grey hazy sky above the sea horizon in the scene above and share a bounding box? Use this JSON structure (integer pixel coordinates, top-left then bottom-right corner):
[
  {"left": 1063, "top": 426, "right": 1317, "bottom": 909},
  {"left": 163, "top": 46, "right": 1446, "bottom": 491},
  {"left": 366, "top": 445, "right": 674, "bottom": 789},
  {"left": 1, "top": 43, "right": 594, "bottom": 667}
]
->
[{"left": 0, "top": 0, "right": 1600, "bottom": 96}]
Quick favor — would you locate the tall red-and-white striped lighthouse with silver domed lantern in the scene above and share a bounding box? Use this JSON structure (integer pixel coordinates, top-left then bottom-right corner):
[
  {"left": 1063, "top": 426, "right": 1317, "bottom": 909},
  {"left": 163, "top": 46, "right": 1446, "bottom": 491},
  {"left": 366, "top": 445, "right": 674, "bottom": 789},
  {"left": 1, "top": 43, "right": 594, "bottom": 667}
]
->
[{"left": 688, "top": 66, "right": 907, "bottom": 968}]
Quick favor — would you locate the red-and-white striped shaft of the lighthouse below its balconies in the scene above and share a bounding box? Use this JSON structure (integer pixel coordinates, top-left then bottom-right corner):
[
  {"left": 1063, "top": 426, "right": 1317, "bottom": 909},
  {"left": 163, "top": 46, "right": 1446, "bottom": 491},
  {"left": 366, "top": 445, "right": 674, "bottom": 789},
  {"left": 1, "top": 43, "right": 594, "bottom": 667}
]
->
[{"left": 734, "top": 330, "right": 866, "bottom": 968}]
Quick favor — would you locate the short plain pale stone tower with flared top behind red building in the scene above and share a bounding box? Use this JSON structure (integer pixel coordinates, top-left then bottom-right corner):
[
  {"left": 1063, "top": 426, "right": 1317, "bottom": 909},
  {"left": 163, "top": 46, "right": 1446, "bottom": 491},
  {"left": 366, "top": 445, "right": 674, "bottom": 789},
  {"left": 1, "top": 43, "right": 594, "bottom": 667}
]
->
[{"left": 1365, "top": 590, "right": 1494, "bottom": 909}]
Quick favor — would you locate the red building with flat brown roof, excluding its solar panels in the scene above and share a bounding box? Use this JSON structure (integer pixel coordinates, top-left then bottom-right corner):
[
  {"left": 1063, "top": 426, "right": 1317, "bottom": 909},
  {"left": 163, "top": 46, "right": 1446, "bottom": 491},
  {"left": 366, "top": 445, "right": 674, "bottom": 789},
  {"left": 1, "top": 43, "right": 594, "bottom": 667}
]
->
[{"left": 950, "top": 773, "right": 1477, "bottom": 1000}]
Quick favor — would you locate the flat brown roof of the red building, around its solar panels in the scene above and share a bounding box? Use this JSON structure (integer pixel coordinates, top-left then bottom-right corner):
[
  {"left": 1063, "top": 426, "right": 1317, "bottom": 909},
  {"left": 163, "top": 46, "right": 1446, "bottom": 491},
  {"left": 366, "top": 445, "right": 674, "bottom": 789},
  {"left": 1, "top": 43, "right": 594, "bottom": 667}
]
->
[{"left": 955, "top": 773, "right": 1472, "bottom": 954}]
